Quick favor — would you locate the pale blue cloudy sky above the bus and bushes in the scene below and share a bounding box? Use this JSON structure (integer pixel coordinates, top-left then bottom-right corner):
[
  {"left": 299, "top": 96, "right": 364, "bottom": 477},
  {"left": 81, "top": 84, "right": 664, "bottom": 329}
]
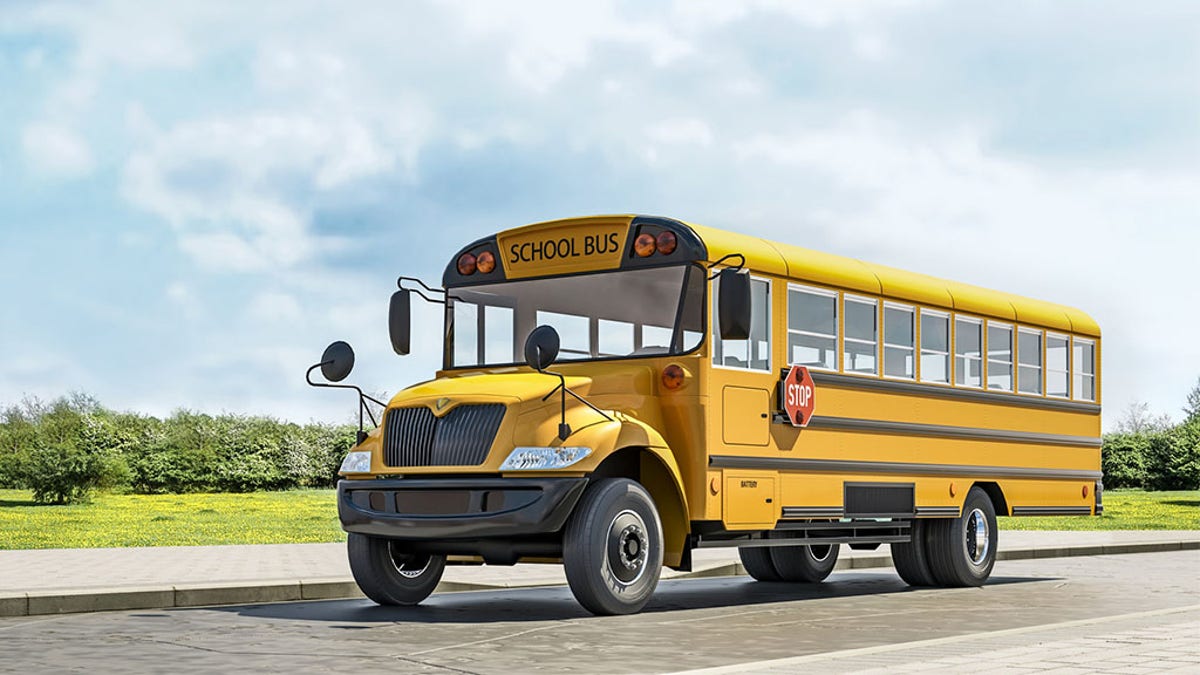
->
[{"left": 0, "top": 0, "right": 1200, "bottom": 428}]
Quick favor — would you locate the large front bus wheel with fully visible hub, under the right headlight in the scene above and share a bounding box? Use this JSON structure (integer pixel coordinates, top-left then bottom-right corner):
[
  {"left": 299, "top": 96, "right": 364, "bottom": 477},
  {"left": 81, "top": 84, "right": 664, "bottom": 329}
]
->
[{"left": 563, "top": 478, "right": 662, "bottom": 615}]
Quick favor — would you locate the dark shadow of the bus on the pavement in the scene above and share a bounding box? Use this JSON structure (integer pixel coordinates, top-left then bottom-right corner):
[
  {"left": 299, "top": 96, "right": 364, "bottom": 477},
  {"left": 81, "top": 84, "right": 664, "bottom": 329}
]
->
[{"left": 220, "top": 573, "right": 1058, "bottom": 628}]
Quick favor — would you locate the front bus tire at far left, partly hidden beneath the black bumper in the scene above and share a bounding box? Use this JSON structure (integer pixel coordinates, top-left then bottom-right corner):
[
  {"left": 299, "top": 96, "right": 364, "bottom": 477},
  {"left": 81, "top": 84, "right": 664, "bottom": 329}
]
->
[{"left": 346, "top": 532, "right": 446, "bottom": 605}]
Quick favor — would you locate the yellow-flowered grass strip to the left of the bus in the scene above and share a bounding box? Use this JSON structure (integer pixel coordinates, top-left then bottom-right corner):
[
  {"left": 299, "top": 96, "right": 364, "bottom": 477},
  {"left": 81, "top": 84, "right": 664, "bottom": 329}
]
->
[{"left": 0, "top": 490, "right": 346, "bottom": 549}]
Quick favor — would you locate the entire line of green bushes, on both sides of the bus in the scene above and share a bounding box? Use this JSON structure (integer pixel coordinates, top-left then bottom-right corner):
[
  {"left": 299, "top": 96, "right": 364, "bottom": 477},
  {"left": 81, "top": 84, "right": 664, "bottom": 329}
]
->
[{"left": 0, "top": 380, "right": 1200, "bottom": 503}]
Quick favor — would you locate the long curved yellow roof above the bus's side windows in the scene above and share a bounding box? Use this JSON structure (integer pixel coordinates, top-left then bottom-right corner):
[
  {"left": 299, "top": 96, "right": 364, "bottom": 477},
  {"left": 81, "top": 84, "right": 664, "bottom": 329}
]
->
[{"left": 686, "top": 223, "right": 1100, "bottom": 338}]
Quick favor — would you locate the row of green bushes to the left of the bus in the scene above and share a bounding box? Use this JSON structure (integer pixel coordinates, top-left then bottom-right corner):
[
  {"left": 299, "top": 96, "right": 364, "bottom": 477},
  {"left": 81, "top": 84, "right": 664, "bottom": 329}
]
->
[{"left": 0, "top": 394, "right": 356, "bottom": 503}]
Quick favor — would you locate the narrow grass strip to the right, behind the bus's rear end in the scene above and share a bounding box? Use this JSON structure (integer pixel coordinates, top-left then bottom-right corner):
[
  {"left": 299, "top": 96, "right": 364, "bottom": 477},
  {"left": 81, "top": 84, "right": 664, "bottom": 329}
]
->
[{"left": 1000, "top": 490, "right": 1200, "bottom": 530}]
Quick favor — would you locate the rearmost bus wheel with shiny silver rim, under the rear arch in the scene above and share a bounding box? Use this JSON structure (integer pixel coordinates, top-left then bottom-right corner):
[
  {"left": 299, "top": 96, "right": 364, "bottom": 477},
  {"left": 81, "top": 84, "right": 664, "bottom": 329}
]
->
[{"left": 925, "top": 486, "right": 997, "bottom": 586}]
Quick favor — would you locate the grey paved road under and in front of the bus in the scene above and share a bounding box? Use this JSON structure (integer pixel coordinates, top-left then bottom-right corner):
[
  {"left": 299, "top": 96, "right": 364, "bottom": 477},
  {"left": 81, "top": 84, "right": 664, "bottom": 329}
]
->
[{"left": 0, "top": 551, "right": 1200, "bottom": 674}]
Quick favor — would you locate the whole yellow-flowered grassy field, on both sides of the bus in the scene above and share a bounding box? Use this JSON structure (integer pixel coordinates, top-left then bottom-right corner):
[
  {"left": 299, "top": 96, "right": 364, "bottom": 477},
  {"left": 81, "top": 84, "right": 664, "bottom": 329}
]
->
[{"left": 0, "top": 490, "right": 1200, "bottom": 549}]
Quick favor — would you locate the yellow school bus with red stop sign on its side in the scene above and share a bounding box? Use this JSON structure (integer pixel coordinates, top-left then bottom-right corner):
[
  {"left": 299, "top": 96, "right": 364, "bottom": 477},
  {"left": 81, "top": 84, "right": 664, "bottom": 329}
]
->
[{"left": 310, "top": 215, "right": 1103, "bottom": 614}]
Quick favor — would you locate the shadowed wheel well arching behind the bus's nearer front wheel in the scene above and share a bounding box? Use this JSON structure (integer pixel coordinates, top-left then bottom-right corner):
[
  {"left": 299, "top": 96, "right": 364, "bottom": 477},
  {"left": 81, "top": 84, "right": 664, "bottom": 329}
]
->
[{"left": 590, "top": 447, "right": 690, "bottom": 568}]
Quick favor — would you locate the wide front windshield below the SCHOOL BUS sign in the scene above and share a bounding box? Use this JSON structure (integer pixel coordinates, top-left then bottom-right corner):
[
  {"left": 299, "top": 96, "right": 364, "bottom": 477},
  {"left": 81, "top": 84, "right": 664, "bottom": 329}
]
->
[{"left": 445, "top": 265, "right": 706, "bottom": 368}]
